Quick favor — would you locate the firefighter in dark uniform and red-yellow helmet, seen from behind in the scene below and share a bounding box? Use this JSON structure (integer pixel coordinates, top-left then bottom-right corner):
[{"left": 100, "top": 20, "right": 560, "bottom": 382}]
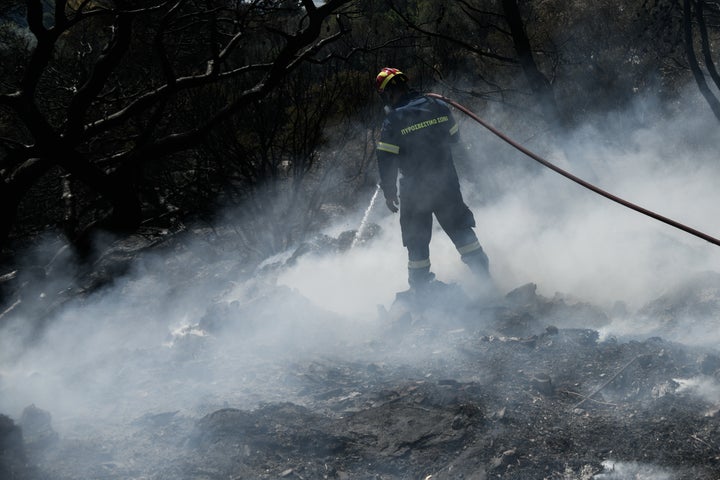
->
[{"left": 376, "top": 67, "right": 490, "bottom": 291}]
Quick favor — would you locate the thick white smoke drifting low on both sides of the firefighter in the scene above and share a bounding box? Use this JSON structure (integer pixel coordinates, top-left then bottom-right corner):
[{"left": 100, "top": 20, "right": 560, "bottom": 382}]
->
[{"left": 0, "top": 86, "right": 720, "bottom": 478}]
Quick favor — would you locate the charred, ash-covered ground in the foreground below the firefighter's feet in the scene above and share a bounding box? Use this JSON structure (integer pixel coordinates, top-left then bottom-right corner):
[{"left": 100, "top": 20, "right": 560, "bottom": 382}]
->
[{"left": 0, "top": 228, "right": 720, "bottom": 480}]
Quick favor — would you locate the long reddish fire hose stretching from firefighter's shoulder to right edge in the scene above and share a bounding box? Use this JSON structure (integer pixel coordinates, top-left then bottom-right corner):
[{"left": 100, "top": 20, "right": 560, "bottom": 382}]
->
[{"left": 425, "top": 93, "right": 720, "bottom": 246}]
